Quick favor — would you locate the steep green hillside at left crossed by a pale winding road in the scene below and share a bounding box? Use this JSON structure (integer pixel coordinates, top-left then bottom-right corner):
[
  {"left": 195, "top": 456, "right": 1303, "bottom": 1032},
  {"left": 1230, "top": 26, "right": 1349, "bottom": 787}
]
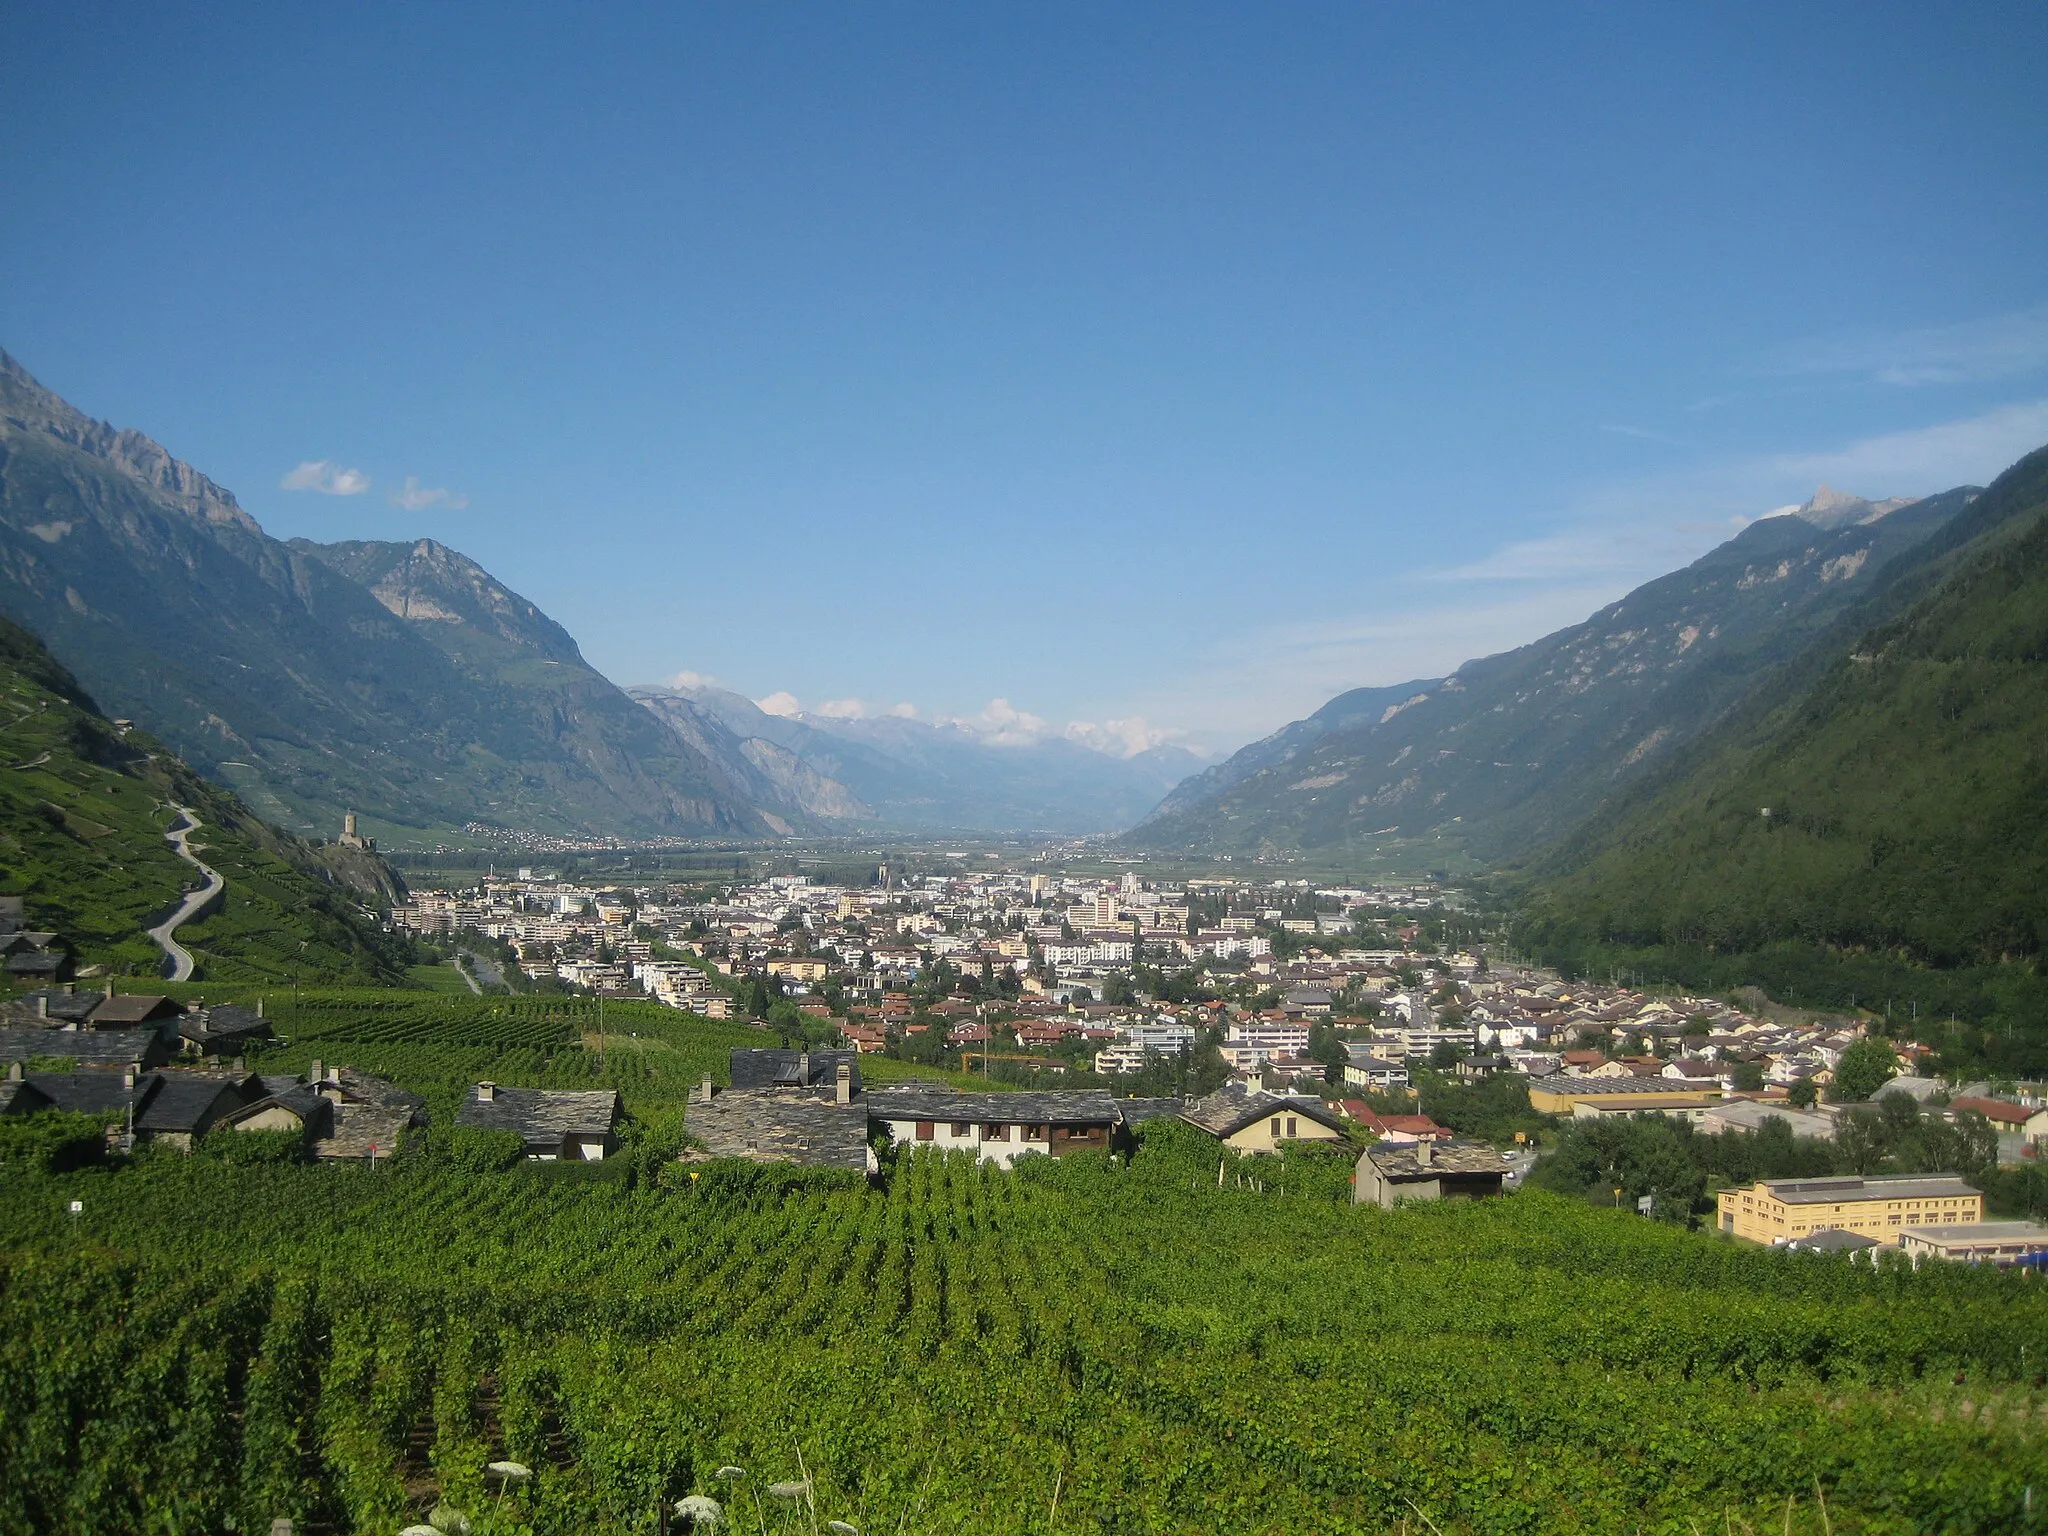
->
[{"left": 0, "top": 618, "right": 401, "bottom": 981}]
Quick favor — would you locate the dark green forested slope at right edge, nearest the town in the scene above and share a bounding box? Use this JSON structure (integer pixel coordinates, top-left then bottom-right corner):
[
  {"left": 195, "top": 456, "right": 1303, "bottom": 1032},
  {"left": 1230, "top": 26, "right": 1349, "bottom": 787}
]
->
[{"left": 1530, "top": 449, "right": 2048, "bottom": 967}]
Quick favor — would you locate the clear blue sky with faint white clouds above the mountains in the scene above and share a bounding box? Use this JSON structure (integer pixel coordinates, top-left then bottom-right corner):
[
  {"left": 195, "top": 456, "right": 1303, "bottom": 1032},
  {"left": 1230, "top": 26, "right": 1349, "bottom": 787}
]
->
[{"left": 0, "top": 4, "right": 2048, "bottom": 750}]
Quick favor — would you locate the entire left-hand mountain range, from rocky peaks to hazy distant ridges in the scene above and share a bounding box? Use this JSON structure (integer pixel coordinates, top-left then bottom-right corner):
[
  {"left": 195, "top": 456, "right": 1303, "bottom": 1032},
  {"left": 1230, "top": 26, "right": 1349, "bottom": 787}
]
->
[{"left": 0, "top": 352, "right": 1198, "bottom": 838}]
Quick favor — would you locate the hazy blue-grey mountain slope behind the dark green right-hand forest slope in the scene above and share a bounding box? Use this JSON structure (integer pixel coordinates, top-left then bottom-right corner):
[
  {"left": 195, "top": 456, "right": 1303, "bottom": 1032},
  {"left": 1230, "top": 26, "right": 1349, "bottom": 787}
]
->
[{"left": 1126, "top": 487, "right": 1974, "bottom": 860}]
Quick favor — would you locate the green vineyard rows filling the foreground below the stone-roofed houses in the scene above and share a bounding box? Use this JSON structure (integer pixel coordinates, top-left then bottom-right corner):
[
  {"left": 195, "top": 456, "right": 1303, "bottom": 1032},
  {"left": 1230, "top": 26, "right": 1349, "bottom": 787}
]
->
[{"left": 0, "top": 1105, "right": 2048, "bottom": 1536}]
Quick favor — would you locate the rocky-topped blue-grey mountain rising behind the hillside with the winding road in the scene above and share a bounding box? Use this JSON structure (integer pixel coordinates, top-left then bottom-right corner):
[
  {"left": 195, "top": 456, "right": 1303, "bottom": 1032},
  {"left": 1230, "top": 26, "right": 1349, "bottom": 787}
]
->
[{"left": 0, "top": 352, "right": 768, "bottom": 836}]
